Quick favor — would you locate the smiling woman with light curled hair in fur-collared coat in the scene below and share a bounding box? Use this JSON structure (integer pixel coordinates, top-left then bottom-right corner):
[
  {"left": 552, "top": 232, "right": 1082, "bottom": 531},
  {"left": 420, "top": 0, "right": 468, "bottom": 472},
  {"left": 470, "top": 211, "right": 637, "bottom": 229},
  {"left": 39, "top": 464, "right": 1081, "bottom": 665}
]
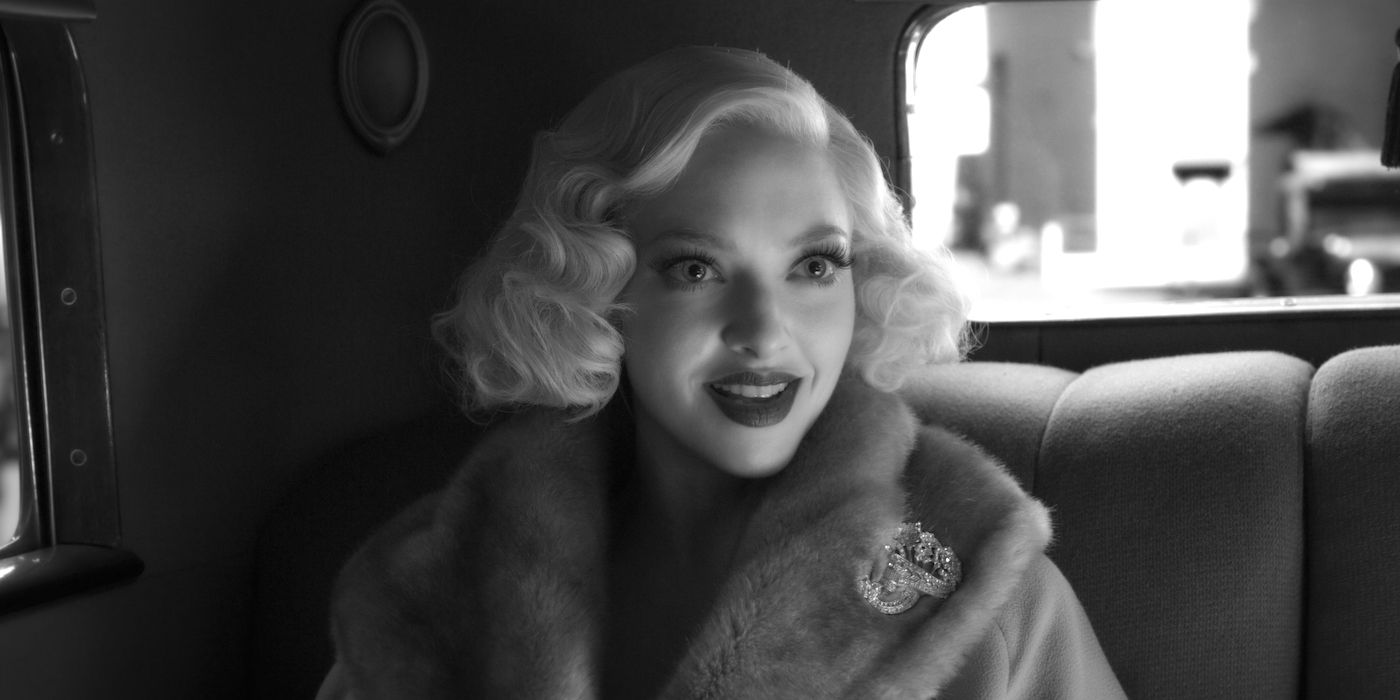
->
[{"left": 322, "top": 49, "right": 1121, "bottom": 699}]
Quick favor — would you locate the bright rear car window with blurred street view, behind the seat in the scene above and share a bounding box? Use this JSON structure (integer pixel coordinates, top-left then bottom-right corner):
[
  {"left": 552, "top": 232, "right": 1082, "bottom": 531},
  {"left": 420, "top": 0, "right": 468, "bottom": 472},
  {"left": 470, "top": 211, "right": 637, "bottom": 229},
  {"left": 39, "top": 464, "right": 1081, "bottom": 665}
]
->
[{"left": 904, "top": 0, "right": 1400, "bottom": 319}]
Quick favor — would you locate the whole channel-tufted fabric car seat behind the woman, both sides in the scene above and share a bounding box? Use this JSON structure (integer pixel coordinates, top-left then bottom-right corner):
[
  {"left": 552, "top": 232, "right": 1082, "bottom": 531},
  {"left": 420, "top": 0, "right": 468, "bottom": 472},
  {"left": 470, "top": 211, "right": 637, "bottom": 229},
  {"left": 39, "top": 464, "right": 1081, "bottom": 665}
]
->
[{"left": 252, "top": 346, "right": 1400, "bottom": 699}]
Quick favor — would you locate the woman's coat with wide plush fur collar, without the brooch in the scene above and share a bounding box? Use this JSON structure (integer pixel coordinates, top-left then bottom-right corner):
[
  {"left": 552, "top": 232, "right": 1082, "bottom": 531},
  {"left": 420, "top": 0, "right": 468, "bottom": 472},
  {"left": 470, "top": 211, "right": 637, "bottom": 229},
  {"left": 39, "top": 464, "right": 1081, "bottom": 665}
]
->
[{"left": 321, "top": 378, "right": 1121, "bottom": 700}]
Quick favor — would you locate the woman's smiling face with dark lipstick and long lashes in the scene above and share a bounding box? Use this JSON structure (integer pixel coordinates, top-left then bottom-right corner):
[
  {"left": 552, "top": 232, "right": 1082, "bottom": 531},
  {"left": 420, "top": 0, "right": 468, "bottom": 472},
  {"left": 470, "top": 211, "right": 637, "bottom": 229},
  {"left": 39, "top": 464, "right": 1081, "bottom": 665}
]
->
[{"left": 622, "top": 127, "right": 855, "bottom": 477}]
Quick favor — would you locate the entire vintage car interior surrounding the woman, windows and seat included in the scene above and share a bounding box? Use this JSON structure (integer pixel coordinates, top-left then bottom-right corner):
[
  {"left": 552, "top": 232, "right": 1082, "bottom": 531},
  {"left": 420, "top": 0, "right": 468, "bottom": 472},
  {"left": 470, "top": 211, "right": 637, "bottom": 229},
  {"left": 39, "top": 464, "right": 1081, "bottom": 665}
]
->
[{"left": 0, "top": 0, "right": 1400, "bottom": 699}]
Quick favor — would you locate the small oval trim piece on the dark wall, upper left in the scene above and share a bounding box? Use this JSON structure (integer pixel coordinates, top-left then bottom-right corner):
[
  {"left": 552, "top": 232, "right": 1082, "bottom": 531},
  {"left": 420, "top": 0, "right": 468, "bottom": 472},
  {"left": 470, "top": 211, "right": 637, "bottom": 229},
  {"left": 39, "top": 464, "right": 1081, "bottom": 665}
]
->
[{"left": 339, "top": 0, "right": 428, "bottom": 155}]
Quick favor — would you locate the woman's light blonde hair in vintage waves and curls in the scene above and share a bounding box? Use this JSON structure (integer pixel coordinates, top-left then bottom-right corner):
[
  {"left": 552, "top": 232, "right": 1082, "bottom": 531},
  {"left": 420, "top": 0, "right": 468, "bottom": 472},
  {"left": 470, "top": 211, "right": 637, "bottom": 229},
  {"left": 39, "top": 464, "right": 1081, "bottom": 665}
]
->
[{"left": 433, "top": 48, "right": 966, "bottom": 414}]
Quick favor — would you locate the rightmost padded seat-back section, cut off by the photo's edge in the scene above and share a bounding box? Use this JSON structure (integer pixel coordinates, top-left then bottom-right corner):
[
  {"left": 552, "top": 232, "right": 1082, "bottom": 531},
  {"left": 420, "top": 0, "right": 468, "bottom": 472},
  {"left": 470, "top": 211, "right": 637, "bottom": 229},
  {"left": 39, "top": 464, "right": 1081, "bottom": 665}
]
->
[{"left": 1305, "top": 346, "right": 1400, "bottom": 697}]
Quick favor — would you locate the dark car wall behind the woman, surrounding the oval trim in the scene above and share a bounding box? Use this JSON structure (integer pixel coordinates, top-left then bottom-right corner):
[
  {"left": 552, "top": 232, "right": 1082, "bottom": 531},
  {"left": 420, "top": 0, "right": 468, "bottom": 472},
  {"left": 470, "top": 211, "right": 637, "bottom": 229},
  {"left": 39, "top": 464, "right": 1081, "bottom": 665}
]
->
[{"left": 0, "top": 0, "right": 917, "bottom": 699}]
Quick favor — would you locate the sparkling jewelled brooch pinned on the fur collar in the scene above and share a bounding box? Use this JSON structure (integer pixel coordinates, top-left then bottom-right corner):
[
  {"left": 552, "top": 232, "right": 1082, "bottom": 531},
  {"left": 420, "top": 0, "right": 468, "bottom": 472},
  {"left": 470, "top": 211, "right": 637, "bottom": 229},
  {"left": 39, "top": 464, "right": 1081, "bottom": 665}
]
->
[{"left": 855, "top": 522, "right": 962, "bottom": 615}]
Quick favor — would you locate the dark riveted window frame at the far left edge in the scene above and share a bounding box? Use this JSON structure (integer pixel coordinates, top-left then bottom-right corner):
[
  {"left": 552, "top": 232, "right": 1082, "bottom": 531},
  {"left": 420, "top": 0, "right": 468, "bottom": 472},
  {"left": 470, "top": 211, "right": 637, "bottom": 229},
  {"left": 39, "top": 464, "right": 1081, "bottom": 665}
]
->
[{"left": 0, "top": 9, "right": 143, "bottom": 615}]
